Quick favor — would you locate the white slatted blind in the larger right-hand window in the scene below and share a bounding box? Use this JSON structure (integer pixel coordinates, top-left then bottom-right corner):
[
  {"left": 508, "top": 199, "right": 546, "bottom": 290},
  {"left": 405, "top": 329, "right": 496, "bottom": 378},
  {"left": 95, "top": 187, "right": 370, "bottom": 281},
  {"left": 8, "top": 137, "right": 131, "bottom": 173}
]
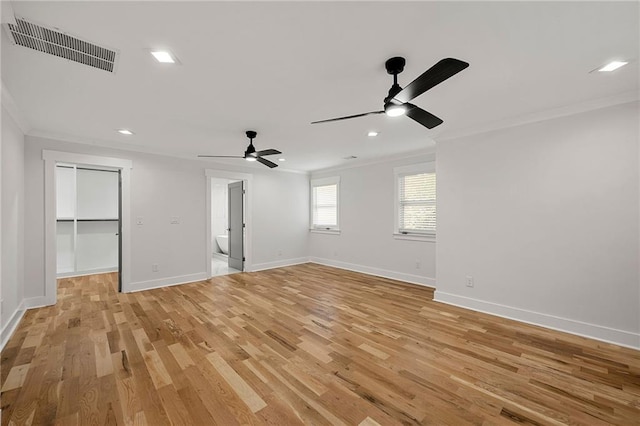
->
[{"left": 398, "top": 173, "right": 436, "bottom": 234}]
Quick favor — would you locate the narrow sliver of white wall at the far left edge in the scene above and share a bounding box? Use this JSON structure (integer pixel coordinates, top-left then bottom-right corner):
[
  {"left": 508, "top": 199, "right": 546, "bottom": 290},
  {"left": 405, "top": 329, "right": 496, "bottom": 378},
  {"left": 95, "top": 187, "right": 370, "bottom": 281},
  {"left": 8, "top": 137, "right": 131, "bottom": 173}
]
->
[{"left": 0, "top": 107, "right": 24, "bottom": 347}]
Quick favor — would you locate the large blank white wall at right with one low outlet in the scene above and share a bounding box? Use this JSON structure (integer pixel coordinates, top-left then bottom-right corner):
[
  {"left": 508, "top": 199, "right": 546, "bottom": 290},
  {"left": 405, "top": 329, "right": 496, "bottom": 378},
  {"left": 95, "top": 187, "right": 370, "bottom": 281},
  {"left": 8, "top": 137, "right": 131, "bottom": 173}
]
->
[{"left": 436, "top": 103, "right": 640, "bottom": 347}]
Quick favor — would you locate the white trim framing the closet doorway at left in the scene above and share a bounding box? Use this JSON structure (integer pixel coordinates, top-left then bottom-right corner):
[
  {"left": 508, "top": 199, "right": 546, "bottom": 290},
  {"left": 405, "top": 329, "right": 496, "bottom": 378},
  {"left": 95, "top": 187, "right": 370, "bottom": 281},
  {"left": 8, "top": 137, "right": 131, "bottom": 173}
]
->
[{"left": 42, "top": 149, "right": 133, "bottom": 305}]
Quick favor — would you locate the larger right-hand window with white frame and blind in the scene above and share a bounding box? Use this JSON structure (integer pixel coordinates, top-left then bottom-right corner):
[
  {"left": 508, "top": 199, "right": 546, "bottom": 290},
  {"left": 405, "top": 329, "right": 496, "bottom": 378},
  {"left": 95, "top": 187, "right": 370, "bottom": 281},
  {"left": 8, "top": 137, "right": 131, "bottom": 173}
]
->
[{"left": 394, "top": 163, "right": 436, "bottom": 239}]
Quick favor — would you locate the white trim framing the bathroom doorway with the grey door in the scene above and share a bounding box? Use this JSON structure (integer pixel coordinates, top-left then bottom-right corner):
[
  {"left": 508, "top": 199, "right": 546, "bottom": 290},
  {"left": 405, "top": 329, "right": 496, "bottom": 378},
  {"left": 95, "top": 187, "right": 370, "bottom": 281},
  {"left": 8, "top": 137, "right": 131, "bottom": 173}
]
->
[{"left": 204, "top": 169, "right": 253, "bottom": 278}]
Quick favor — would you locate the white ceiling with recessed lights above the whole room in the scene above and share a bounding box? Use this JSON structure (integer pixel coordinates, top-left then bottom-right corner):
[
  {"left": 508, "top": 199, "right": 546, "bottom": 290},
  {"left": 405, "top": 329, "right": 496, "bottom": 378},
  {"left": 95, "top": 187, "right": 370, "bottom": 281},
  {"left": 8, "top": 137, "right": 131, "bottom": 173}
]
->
[{"left": 1, "top": 1, "right": 640, "bottom": 171}]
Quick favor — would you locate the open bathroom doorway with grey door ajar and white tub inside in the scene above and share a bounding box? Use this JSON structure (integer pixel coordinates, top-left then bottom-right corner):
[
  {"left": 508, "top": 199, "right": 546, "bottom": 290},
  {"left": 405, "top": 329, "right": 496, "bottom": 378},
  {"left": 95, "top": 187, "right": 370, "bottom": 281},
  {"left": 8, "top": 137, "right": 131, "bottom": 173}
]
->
[{"left": 205, "top": 170, "right": 253, "bottom": 277}]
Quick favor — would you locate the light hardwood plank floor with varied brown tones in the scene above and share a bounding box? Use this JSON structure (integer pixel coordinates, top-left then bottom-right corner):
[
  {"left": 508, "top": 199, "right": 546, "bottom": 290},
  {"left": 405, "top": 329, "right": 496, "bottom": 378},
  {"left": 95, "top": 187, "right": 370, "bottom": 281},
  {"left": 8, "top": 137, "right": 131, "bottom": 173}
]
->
[{"left": 2, "top": 264, "right": 640, "bottom": 426}]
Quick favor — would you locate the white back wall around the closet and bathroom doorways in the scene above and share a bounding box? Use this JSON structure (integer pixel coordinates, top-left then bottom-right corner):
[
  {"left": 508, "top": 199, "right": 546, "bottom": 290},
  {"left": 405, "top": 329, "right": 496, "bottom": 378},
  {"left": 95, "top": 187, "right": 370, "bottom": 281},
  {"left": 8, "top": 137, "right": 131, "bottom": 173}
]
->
[{"left": 25, "top": 137, "right": 307, "bottom": 298}]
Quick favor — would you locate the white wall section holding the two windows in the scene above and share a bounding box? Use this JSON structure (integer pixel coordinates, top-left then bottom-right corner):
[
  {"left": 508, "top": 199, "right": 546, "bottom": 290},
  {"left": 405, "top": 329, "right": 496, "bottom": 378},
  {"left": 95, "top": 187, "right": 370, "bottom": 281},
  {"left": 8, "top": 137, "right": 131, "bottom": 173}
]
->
[{"left": 306, "top": 154, "right": 436, "bottom": 286}]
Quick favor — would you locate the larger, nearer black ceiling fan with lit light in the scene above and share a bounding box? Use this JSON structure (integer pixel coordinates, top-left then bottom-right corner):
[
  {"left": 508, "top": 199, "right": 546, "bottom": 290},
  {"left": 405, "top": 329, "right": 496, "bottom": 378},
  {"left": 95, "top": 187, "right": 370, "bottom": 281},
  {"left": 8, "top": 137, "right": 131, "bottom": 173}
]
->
[{"left": 311, "top": 57, "right": 469, "bottom": 129}]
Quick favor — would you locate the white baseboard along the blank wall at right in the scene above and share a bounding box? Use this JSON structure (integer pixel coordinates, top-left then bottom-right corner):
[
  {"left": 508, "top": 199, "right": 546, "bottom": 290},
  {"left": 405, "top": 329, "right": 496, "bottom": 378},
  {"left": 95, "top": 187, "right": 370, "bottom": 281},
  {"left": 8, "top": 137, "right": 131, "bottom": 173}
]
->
[{"left": 434, "top": 290, "right": 640, "bottom": 349}]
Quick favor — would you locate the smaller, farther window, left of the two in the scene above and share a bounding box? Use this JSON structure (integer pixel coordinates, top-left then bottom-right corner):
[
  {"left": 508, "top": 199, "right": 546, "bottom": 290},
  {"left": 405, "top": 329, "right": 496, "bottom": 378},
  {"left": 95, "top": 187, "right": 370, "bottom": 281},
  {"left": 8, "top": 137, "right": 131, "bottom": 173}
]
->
[{"left": 311, "top": 177, "right": 340, "bottom": 232}]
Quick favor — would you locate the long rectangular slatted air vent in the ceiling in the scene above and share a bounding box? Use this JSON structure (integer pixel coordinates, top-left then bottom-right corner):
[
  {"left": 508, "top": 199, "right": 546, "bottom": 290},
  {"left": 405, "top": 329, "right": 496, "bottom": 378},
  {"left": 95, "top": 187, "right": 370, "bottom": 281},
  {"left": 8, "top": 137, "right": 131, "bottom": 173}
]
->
[{"left": 4, "top": 18, "right": 117, "bottom": 72}]
